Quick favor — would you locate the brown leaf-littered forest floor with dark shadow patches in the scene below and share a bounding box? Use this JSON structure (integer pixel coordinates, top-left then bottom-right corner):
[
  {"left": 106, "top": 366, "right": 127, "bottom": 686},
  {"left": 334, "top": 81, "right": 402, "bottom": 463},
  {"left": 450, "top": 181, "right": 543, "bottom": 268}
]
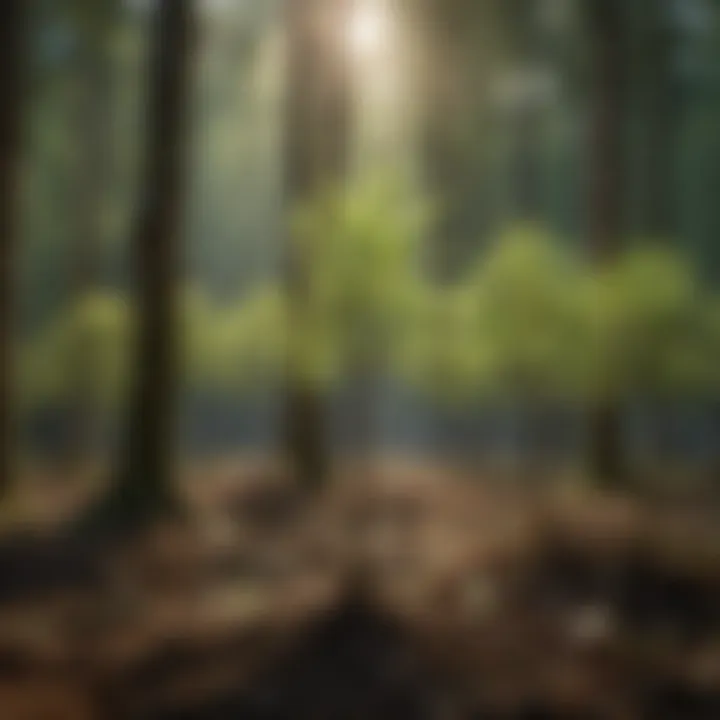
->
[{"left": 0, "top": 463, "right": 720, "bottom": 720}]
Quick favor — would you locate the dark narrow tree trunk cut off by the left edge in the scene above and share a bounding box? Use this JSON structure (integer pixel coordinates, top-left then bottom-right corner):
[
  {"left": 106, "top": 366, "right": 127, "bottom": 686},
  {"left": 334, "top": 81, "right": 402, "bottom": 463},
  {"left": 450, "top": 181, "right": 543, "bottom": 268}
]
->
[{"left": 0, "top": 0, "right": 27, "bottom": 492}]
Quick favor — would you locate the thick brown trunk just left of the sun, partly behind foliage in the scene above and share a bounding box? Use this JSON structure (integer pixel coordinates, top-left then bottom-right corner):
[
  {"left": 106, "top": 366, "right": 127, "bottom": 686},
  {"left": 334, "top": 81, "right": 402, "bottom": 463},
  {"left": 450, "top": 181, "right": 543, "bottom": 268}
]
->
[{"left": 283, "top": 0, "right": 353, "bottom": 489}]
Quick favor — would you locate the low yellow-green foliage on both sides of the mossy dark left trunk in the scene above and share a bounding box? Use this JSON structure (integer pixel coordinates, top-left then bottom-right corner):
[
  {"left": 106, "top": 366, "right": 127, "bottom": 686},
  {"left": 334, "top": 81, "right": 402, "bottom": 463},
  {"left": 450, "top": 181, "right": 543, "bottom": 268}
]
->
[{"left": 18, "top": 286, "right": 286, "bottom": 411}]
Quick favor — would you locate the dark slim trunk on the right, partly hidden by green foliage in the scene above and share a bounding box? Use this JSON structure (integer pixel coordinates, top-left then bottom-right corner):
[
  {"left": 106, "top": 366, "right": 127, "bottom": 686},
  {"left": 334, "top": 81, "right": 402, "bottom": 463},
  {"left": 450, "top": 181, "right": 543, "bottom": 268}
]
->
[{"left": 587, "top": 0, "right": 627, "bottom": 485}]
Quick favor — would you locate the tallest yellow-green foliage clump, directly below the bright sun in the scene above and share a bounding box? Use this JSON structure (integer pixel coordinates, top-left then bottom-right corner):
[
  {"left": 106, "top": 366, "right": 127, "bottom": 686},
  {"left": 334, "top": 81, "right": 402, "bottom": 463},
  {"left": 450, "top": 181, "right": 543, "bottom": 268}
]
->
[{"left": 289, "top": 178, "right": 430, "bottom": 382}]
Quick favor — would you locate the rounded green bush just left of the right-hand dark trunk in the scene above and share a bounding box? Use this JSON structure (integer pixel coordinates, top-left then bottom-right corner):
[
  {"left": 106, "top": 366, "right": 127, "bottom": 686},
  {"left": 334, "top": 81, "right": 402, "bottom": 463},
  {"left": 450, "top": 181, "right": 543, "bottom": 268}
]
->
[{"left": 409, "top": 227, "right": 590, "bottom": 401}]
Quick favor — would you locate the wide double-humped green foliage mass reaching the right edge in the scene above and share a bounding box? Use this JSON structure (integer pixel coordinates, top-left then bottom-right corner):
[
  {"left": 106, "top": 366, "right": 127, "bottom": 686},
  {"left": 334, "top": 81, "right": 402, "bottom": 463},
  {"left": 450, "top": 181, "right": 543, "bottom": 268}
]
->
[{"left": 403, "top": 227, "right": 720, "bottom": 402}]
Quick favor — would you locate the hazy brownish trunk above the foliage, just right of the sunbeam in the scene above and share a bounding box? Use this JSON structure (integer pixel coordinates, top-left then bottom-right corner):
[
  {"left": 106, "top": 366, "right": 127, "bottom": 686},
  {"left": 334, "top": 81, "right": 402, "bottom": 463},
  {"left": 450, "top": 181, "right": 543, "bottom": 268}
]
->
[{"left": 413, "top": 0, "right": 509, "bottom": 281}]
